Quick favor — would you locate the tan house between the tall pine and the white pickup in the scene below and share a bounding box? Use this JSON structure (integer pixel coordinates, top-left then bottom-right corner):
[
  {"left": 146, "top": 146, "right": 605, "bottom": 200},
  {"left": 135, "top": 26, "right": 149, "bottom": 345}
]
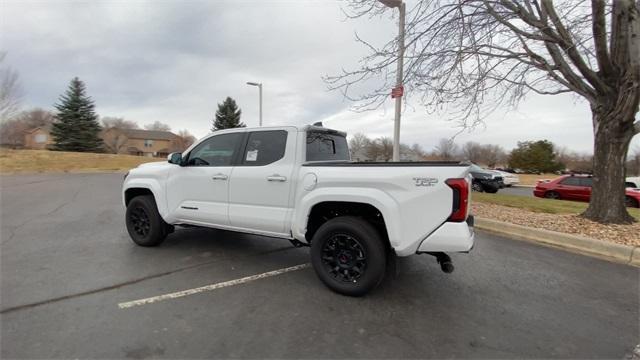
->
[{"left": 102, "top": 128, "right": 184, "bottom": 157}]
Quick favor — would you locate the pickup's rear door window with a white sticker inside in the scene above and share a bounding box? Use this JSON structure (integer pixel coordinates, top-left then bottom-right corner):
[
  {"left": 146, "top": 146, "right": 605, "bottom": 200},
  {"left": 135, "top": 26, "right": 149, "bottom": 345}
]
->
[{"left": 242, "top": 130, "right": 287, "bottom": 166}]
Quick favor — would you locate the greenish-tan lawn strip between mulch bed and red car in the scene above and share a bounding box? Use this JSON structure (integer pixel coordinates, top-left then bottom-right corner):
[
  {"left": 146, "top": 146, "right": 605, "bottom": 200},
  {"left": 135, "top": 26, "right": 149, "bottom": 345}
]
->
[{"left": 471, "top": 192, "right": 640, "bottom": 220}]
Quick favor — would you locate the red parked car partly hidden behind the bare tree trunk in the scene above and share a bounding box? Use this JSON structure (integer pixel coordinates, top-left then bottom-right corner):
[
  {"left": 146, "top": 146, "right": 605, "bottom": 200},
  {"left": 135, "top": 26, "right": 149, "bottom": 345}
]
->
[{"left": 533, "top": 175, "right": 640, "bottom": 207}]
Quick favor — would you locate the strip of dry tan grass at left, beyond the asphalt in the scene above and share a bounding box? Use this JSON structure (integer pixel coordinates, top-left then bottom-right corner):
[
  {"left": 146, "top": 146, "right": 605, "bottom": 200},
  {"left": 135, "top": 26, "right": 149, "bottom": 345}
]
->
[{"left": 0, "top": 149, "right": 163, "bottom": 175}]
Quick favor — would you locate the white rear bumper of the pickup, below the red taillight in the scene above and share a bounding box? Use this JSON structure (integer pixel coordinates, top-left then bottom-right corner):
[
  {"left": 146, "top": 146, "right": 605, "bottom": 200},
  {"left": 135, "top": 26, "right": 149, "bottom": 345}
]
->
[{"left": 417, "top": 215, "right": 475, "bottom": 253}]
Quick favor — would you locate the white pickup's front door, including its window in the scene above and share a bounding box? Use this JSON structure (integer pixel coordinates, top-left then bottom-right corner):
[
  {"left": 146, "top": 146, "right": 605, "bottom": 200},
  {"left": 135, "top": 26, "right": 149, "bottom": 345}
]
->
[{"left": 167, "top": 132, "right": 244, "bottom": 225}]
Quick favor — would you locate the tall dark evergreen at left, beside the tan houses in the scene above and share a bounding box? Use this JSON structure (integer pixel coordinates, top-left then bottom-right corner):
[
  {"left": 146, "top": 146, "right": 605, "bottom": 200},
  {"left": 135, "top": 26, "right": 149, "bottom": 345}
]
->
[{"left": 51, "top": 77, "right": 103, "bottom": 152}]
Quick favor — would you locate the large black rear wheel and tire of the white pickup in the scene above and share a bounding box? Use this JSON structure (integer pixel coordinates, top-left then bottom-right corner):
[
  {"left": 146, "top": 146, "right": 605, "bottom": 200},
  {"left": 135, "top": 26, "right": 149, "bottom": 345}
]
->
[{"left": 311, "top": 216, "right": 386, "bottom": 296}]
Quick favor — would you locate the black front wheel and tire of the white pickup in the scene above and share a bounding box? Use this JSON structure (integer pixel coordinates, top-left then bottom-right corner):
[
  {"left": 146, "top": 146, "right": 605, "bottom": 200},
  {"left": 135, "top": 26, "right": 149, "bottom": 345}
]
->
[{"left": 126, "top": 195, "right": 170, "bottom": 246}]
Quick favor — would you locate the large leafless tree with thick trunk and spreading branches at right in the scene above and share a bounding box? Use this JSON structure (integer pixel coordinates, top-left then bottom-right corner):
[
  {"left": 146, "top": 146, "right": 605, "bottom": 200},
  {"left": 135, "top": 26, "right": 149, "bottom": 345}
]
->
[{"left": 325, "top": 0, "right": 640, "bottom": 223}]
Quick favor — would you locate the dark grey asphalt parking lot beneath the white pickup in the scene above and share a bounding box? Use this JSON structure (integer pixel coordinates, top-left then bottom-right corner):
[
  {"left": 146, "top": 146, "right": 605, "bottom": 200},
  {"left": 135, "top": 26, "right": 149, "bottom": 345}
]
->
[{"left": 0, "top": 174, "right": 640, "bottom": 359}]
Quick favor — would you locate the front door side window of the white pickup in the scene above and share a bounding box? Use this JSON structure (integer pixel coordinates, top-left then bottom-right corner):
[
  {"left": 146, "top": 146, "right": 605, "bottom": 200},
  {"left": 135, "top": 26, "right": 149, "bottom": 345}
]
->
[{"left": 186, "top": 133, "right": 243, "bottom": 166}]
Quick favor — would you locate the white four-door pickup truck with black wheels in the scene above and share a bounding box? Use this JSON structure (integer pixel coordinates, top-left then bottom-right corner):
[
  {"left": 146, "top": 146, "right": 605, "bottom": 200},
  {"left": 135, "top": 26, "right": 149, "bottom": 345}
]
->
[{"left": 122, "top": 125, "right": 474, "bottom": 296}]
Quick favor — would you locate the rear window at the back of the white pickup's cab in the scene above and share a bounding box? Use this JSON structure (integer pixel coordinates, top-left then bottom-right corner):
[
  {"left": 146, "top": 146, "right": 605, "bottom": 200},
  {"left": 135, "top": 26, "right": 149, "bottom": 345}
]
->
[{"left": 306, "top": 131, "right": 351, "bottom": 161}]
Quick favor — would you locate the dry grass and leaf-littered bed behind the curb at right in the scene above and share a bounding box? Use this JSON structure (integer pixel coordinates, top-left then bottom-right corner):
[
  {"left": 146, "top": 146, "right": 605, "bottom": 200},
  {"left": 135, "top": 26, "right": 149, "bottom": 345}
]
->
[{"left": 472, "top": 193, "right": 640, "bottom": 246}]
